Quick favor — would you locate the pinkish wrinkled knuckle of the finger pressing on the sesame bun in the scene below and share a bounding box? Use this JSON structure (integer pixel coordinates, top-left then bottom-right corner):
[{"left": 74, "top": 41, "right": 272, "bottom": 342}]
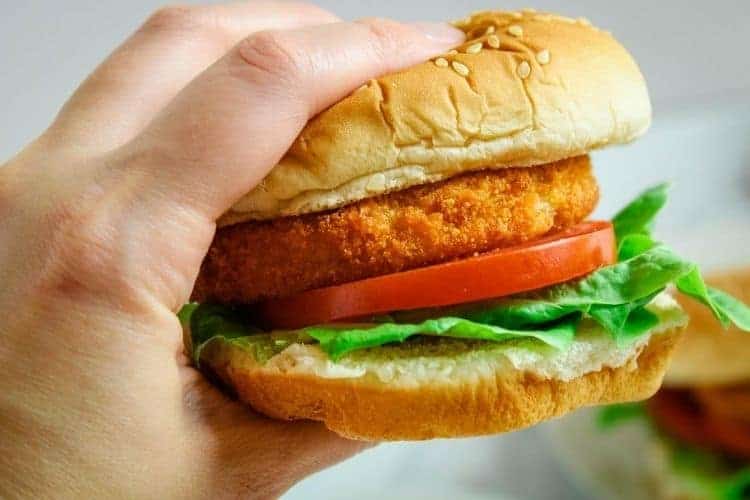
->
[{"left": 237, "top": 31, "right": 307, "bottom": 84}]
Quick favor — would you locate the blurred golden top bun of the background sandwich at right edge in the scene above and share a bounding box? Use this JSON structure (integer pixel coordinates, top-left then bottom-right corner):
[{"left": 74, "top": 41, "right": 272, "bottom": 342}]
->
[{"left": 664, "top": 268, "right": 750, "bottom": 387}]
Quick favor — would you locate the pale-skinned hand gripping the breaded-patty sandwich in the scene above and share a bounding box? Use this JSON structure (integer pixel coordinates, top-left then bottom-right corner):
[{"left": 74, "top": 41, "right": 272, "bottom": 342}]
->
[{"left": 0, "top": 2, "right": 462, "bottom": 498}]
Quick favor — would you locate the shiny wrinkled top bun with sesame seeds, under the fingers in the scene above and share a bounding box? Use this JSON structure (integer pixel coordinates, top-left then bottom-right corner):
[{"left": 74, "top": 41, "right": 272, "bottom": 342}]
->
[{"left": 219, "top": 10, "right": 651, "bottom": 225}]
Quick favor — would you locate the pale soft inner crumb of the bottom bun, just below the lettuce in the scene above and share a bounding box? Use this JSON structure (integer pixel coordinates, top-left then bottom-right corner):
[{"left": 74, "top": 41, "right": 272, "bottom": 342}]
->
[{"left": 189, "top": 293, "right": 687, "bottom": 386}]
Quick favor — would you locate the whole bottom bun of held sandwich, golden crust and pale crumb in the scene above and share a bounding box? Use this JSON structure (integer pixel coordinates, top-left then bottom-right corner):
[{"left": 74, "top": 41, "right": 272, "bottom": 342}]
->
[{"left": 201, "top": 321, "right": 683, "bottom": 441}]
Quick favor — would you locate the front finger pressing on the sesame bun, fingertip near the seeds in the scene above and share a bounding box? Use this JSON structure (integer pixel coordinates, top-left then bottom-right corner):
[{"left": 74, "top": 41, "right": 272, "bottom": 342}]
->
[{"left": 125, "top": 20, "right": 463, "bottom": 219}]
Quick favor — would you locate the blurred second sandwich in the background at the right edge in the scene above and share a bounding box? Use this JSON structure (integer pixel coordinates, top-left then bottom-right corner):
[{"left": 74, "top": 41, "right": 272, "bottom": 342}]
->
[{"left": 645, "top": 269, "right": 750, "bottom": 500}]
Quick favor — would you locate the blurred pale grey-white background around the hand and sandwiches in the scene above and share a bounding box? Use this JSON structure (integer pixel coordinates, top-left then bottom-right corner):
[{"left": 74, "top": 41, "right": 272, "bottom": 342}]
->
[{"left": 0, "top": 0, "right": 750, "bottom": 500}]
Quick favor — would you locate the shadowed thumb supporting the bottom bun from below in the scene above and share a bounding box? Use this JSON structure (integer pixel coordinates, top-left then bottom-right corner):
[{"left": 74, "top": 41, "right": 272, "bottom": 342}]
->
[{"left": 183, "top": 365, "right": 376, "bottom": 498}]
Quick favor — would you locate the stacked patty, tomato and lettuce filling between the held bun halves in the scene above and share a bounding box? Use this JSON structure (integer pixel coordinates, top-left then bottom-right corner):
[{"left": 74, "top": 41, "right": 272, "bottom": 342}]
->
[{"left": 181, "top": 164, "right": 750, "bottom": 378}]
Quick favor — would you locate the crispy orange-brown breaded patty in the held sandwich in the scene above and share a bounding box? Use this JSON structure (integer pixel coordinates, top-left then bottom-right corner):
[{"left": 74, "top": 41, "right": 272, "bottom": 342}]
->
[{"left": 193, "top": 156, "right": 599, "bottom": 304}]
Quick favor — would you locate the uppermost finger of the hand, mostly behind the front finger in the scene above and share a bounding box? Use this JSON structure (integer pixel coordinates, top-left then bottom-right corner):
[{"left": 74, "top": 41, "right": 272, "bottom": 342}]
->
[{"left": 51, "top": 1, "right": 338, "bottom": 152}]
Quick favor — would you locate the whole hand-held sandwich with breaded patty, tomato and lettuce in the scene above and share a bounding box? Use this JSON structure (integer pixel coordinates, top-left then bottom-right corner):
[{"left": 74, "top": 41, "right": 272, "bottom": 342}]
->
[{"left": 180, "top": 9, "right": 750, "bottom": 440}]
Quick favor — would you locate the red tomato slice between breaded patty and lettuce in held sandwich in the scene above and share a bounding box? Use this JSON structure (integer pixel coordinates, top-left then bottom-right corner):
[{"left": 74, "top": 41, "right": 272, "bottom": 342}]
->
[{"left": 257, "top": 221, "right": 616, "bottom": 328}]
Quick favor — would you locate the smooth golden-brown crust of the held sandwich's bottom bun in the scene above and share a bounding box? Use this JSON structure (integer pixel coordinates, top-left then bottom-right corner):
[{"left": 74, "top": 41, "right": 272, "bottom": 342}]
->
[{"left": 203, "top": 328, "right": 682, "bottom": 441}]
